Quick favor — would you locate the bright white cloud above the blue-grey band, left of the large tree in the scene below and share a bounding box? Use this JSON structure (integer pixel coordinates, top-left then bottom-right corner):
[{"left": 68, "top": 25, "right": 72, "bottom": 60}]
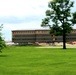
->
[{"left": 0, "top": 0, "right": 49, "bottom": 17}]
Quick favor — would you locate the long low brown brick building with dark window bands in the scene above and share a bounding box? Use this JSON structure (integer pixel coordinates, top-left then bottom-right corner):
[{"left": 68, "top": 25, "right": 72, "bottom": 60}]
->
[{"left": 12, "top": 29, "right": 76, "bottom": 43}]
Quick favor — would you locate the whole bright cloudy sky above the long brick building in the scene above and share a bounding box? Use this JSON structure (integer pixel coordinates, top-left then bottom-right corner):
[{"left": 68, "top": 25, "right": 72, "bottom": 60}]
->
[{"left": 0, "top": 0, "right": 76, "bottom": 41}]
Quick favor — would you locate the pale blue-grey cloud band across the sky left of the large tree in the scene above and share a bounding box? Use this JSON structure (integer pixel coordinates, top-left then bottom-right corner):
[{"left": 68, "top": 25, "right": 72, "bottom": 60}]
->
[{"left": 0, "top": 15, "right": 42, "bottom": 24}]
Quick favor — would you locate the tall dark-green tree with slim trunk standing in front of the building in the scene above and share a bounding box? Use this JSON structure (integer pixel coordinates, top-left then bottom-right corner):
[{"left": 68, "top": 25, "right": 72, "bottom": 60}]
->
[{"left": 41, "top": 0, "right": 76, "bottom": 49}]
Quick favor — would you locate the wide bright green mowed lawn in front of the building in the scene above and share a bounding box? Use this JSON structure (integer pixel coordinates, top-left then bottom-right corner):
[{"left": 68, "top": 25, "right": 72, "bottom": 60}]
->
[{"left": 0, "top": 47, "right": 76, "bottom": 75}]
